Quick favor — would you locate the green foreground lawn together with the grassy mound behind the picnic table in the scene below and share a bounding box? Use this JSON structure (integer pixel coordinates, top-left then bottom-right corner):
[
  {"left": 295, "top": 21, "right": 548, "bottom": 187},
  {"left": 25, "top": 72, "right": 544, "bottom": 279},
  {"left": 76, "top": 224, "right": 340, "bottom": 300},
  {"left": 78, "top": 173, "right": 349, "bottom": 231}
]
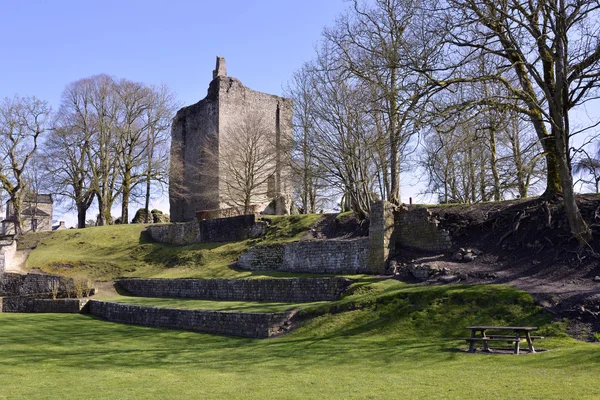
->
[{"left": 0, "top": 281, "right": 600, "bottom": 400}]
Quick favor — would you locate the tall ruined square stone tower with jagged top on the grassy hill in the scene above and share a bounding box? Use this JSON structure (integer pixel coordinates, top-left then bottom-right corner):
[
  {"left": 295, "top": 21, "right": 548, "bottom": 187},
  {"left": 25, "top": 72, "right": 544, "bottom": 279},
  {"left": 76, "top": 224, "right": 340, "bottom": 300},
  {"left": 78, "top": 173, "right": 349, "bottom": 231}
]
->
[{"left": 169, "top": 57, "right": 292, "bottom": 222}]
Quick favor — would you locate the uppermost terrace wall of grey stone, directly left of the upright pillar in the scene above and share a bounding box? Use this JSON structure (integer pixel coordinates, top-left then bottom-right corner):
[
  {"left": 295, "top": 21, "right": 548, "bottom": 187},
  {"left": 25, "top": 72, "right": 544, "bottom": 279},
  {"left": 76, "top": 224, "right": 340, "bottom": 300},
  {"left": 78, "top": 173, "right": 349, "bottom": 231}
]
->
[{"left": 237, "top": 238, "right": 369, "bottom": 274}]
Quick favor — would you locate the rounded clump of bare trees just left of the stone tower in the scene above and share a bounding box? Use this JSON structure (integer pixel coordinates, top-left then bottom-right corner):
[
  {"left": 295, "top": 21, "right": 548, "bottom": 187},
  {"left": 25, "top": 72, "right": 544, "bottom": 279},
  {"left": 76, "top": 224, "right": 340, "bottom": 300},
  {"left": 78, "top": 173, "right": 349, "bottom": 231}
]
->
[{"left": 45, "top": 75, "right": 175, "bottom": 227}]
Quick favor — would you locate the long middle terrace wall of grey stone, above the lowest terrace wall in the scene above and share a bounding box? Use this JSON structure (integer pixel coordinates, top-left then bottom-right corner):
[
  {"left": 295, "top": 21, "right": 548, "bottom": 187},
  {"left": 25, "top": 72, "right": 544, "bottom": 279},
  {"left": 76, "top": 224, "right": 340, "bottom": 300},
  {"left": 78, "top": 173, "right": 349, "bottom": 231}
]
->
[{"left": 116, "top": 278, "right": 352, "bottom": 303}]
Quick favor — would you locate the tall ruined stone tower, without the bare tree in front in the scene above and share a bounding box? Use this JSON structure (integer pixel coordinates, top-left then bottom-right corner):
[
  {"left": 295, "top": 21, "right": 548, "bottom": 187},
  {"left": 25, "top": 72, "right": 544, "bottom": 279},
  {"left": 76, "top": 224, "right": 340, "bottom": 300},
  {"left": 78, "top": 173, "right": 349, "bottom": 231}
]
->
[{"left": 169, "top": 57, "right": 292, "bottom": 222}]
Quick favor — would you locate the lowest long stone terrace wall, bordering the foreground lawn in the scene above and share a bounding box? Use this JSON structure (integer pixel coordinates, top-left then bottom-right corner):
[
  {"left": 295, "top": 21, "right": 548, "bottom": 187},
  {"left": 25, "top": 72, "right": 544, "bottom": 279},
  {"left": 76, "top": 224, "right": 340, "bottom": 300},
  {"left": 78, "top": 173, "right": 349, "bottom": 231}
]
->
[{"left": 87, "top": 300, "right": 295, "bottom": 338}]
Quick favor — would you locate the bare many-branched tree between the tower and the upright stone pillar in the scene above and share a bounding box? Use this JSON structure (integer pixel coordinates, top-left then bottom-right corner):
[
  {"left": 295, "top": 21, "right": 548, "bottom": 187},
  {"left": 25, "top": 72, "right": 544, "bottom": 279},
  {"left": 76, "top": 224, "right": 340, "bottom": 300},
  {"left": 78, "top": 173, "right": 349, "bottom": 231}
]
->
[{"left": 302, "top": 50, "right": 378, "bottom": 217}]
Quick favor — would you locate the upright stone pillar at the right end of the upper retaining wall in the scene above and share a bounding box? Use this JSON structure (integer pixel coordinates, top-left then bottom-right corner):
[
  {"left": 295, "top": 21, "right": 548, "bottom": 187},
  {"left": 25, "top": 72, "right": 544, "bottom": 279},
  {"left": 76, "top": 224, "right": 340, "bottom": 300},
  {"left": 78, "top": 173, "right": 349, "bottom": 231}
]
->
[{"left": 368, "top": 201, "right": 396, "bottom": 274}]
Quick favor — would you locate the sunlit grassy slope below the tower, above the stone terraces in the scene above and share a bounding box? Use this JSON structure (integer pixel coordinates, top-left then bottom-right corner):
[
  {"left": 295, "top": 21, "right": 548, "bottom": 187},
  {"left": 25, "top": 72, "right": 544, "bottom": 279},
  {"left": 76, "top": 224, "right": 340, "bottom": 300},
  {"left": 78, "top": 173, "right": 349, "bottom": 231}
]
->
[{"left": 26, "top": 215, "right": 320, "bottom": 280}]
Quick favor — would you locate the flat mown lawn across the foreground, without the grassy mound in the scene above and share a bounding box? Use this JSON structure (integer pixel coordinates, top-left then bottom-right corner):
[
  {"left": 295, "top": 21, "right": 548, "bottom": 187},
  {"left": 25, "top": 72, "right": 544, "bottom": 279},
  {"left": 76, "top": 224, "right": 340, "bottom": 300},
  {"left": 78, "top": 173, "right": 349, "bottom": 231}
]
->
[{"left": 0, "top": 314, "right": 600, "bottom": 400}]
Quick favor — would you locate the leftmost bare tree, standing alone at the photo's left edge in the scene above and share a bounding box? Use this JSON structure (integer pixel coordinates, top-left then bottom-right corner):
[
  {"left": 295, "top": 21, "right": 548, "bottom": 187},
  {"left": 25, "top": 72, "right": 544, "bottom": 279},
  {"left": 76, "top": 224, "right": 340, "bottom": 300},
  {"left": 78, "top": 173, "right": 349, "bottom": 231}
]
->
[{"left": 0, "top": 96, "right": 51, "bottom": 235}]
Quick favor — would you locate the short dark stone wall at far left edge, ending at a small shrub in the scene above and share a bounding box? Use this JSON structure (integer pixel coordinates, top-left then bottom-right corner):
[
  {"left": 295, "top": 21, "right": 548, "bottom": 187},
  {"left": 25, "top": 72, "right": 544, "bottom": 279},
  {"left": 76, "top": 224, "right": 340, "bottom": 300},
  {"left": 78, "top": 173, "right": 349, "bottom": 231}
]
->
[{"left": 0, "top": 273, "right": 73, "bottom": 296}]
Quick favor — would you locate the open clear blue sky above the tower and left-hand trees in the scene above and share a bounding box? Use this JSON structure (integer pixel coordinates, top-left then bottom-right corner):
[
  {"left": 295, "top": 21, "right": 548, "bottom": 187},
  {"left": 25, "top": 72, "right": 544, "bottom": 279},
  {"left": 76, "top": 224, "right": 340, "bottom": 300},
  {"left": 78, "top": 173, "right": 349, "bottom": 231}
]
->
[{"left": 0, "top": 0, "right": 382, "bottom": 225}]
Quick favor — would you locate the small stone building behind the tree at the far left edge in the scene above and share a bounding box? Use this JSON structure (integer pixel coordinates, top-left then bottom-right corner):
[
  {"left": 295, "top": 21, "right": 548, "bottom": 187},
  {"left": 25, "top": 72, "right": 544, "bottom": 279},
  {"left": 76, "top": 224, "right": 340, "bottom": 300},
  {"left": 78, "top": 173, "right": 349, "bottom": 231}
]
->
[{"left": 0, "top": 194, "right": 54, "bottom": 235}]
